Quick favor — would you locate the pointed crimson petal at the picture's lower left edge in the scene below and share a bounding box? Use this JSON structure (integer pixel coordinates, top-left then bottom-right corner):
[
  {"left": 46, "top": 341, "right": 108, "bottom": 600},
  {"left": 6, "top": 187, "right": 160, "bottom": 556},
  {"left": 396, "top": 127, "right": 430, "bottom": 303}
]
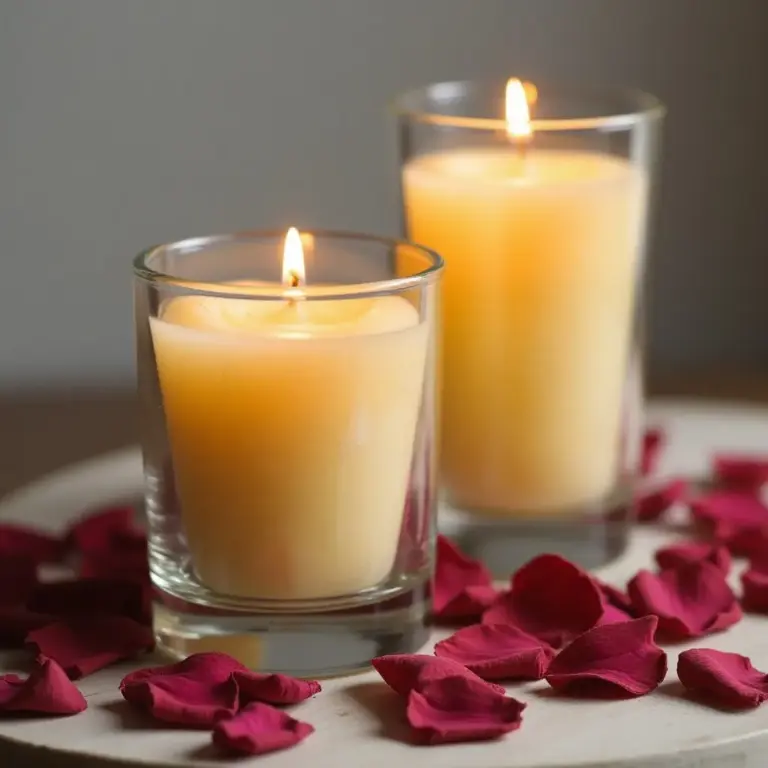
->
[{"left": 0, "top": 658, "right": 88, "bottom": 715}]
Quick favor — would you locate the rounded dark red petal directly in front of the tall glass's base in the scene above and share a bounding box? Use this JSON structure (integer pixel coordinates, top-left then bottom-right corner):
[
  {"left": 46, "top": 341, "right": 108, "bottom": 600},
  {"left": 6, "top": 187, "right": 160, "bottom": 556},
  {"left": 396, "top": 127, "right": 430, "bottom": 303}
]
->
[{"left": 483, "top": 555, "right": 604, "bottom": 648}]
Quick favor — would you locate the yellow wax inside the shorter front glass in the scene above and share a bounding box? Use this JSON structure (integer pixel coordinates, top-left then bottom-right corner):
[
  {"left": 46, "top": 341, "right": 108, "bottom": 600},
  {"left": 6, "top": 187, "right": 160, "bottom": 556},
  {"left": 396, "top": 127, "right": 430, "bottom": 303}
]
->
[{"left": 150, "top": 296, "right": 427, "bottom": 599}]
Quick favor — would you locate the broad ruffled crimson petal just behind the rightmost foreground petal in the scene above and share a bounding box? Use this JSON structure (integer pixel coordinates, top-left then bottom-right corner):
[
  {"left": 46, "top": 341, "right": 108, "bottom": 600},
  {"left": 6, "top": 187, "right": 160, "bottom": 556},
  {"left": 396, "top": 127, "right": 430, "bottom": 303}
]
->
[{"left": 628, "top": 562, "right": 742, "bottom": 641}]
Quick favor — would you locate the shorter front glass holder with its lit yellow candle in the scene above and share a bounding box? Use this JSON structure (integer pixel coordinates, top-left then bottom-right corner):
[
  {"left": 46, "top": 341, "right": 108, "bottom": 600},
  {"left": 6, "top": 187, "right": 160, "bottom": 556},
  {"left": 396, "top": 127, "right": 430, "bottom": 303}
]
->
[{"left": 134, "top": 230, "right": 442, "bottom": 677}]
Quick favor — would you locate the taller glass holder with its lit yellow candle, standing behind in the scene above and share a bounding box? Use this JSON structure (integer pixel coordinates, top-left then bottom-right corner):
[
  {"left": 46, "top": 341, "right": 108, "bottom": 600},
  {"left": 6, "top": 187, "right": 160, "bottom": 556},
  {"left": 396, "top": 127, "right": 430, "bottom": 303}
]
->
[{"left": 396, "top": 79, "right": 663, "bottom": 574}]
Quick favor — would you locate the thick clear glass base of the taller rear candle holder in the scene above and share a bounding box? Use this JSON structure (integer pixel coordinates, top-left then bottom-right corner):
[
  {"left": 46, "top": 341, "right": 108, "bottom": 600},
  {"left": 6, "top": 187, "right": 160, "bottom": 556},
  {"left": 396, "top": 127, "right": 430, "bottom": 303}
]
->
[{"left": 438, "top": 483, "right": 633, "bottom": 580}]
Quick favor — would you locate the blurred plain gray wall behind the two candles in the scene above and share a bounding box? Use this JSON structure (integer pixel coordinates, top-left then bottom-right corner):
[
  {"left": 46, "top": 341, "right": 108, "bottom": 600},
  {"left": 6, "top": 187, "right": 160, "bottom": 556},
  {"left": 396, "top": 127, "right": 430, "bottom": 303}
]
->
[{"left": 0, "top": 0, "right": 768, "bottom": 386}]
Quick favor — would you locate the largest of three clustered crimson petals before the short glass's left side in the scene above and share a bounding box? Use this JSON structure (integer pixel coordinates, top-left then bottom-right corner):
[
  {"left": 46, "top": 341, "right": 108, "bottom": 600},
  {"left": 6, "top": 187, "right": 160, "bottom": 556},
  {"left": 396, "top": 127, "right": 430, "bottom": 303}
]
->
[{"left": 120, "top": 653, "right": 246, "bottom": 728}]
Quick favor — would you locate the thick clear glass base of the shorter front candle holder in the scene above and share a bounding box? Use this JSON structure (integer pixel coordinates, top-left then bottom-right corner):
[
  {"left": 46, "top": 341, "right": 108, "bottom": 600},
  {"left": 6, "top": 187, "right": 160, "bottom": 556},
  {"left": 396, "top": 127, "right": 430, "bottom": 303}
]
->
[{"left": 153, "top": 583, "right": 429, "bottom": 679}]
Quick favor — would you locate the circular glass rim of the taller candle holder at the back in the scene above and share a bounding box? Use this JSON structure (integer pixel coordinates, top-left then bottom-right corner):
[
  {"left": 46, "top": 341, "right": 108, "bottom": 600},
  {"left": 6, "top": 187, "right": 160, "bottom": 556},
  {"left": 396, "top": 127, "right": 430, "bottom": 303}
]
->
[{"left": 391, "top": 77, "right": 666, "bottom": 134}]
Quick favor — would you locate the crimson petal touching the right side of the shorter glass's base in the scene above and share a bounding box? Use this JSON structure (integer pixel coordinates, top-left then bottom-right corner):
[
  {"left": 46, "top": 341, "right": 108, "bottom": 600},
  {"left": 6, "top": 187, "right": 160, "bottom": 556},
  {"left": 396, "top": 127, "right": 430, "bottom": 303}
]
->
[{"left": 432, "top": 535, "right": 497, "bottom": 619}]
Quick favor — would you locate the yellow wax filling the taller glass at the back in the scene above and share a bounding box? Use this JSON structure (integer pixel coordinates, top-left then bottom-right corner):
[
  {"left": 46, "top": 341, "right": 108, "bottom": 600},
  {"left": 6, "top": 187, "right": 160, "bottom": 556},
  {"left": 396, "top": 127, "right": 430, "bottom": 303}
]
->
[{"left": 403, "top": 147, "right": 646, "bottom": 513}]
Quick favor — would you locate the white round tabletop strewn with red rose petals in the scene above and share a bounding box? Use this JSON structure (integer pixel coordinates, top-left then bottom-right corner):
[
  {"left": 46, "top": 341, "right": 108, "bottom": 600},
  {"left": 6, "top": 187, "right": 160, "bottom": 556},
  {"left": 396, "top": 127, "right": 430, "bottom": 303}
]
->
[{"left": 0, "top": 401, "right": 768, "bottom": 768}]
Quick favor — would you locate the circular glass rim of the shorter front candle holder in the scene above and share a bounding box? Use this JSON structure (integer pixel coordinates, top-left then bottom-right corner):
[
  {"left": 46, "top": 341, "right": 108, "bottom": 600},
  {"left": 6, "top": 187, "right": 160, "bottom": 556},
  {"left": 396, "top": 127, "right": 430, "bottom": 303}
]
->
[{"left": 133, "top": 229, "right": 444, "bottom": 301}]
